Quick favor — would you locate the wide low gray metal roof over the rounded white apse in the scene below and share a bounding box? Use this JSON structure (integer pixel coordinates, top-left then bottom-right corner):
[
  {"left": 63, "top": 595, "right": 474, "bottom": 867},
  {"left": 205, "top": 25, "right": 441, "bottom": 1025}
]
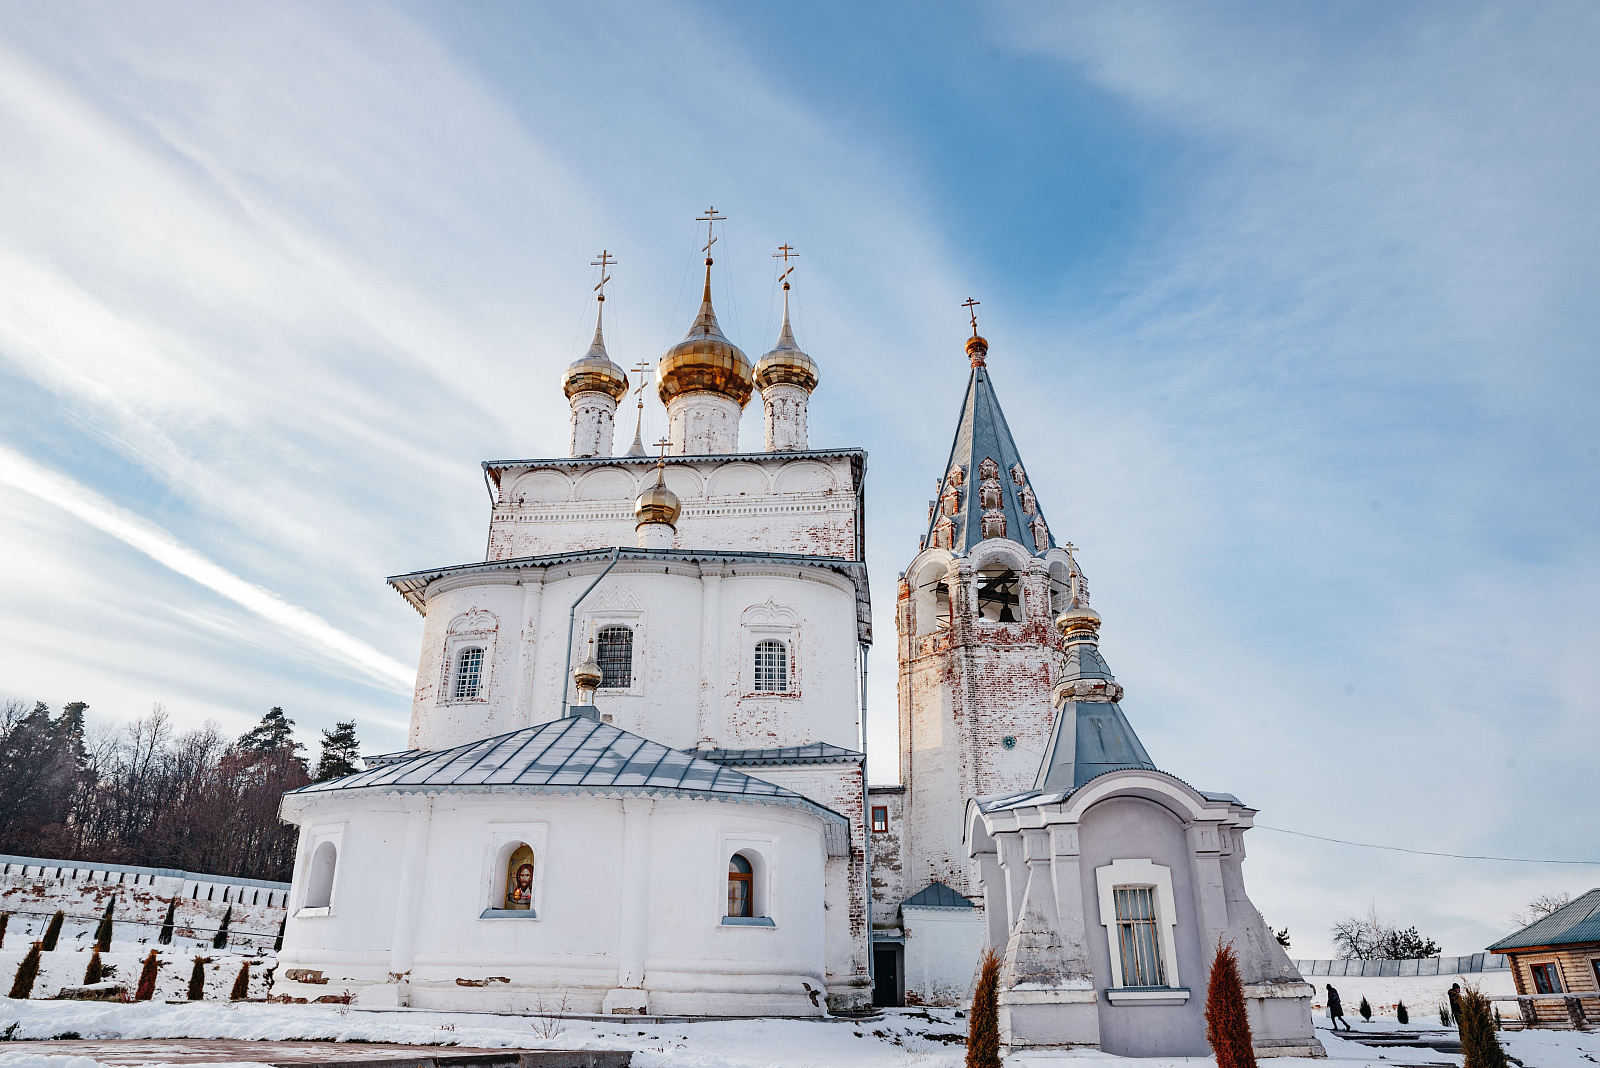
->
[{"left": 290, "top": 716, "right": 850, "bottom": 855}]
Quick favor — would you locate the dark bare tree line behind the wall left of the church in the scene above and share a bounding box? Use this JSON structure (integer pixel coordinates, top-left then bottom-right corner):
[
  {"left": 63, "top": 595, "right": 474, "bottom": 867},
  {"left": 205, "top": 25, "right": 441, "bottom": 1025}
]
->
[{"left": 0, "top": 700, "right": 360, "bottom": 881}]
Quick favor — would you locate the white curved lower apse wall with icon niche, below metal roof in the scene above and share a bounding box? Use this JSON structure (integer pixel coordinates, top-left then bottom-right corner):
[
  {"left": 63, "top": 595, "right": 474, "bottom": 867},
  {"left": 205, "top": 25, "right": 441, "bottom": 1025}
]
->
[{"left": 278, "top": 793, "right": 827, "bottom": 1015}]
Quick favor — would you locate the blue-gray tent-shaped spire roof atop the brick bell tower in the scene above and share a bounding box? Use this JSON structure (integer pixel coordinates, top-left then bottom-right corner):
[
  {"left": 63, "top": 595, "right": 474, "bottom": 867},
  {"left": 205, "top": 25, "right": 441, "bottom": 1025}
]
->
[{"left": 926, "top": 317, "right": 1054, "bottom": 553}]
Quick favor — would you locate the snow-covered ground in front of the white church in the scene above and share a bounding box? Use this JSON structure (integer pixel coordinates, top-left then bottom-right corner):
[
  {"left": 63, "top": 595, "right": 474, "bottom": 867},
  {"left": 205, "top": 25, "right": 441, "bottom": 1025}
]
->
[{"left": 0, "top": 1001, "right": 1600, "bottom": 1068}]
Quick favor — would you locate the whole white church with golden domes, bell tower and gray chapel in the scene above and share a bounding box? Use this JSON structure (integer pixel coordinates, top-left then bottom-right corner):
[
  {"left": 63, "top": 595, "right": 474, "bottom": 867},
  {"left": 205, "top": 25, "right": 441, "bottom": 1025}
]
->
[{"left": 274, "top": 219, "right": 1322, "bottom": 1055}]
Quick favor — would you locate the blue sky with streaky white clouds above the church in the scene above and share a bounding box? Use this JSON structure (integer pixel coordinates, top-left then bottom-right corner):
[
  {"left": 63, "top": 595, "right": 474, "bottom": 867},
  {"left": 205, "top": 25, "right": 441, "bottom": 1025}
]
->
[{"left": 0, "top": 3, "right": 1600, "bottom": 956}]
